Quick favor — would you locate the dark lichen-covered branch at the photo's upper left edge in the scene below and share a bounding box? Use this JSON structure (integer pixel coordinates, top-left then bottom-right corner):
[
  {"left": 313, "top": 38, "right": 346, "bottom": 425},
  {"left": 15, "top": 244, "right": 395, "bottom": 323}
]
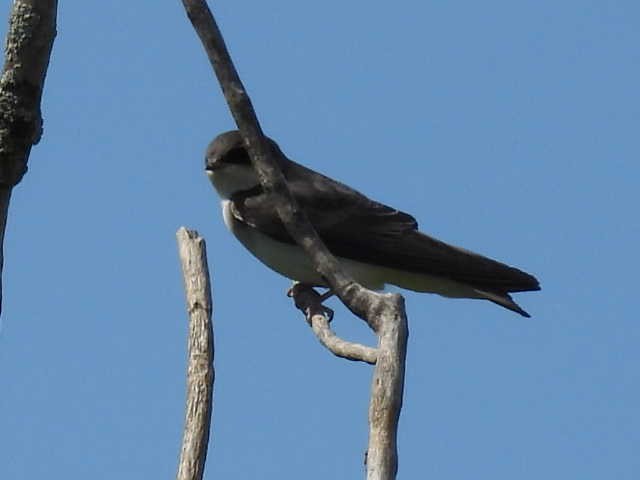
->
[{"left": 0, "top": 0, "right": 58, "bottom": 311}]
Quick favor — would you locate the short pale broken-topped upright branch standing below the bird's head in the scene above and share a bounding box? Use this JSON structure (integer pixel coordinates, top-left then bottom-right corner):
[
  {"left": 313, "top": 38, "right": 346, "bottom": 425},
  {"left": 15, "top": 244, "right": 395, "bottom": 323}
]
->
[{"left": 176, "top": 227, "right": 215, "bottom": 480}]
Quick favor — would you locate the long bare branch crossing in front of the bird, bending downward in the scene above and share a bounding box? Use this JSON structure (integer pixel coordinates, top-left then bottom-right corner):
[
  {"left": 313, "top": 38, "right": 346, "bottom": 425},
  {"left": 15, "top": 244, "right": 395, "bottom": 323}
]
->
[{"left": 182, "top": 0, "right": 408, "bottom": 480}]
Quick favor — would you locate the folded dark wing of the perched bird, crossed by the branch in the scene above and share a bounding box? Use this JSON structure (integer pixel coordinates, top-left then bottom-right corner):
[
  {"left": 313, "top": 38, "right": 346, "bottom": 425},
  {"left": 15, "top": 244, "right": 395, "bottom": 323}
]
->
[{"left": 232, "top": 158, "right": 540, "bottom": 293}]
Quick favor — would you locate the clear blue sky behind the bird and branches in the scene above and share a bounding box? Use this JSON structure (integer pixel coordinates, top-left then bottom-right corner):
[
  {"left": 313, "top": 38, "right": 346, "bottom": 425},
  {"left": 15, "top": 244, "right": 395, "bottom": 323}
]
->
[{"left": 0, "top": 0, "right": 640, "bottom": 480}]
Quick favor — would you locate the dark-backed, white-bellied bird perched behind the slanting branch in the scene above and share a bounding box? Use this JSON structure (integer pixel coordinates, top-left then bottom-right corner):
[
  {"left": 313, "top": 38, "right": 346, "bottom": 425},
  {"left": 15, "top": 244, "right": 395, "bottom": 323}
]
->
[{"left": 205, "top": 130, "right": 540, "bottom": 317}]
